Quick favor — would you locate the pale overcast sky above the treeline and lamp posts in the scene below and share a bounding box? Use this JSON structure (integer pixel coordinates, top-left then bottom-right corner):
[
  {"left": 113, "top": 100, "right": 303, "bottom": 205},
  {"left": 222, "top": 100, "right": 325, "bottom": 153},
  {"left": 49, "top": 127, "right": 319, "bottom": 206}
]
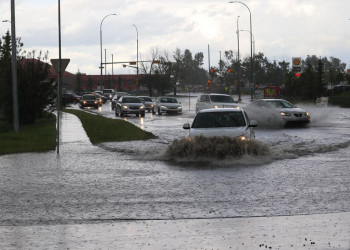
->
[{"left": 0, "top": 0, "right": 350, "bottom": 74}]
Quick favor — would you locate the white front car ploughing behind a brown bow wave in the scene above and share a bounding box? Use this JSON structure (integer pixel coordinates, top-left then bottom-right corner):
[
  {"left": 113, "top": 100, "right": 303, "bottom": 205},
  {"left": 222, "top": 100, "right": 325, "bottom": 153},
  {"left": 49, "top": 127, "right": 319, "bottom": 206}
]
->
[{"left": 183, "top": 108, "right": 258, "bottom": 140}]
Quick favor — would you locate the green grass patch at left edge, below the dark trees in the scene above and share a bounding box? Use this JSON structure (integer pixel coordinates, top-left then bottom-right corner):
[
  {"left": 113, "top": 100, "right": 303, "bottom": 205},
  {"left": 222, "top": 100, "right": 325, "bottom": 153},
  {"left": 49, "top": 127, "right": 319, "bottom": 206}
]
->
[{"left": 0, "top": 114, "right": 56, "bottom": 155}]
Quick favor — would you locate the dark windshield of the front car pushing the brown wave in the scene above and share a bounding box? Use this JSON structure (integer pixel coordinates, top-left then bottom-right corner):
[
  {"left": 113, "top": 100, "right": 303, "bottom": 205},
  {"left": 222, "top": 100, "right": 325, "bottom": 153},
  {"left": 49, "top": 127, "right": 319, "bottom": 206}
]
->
[{"left": 192, "top": 111, "right": 246, "bottom": 128}]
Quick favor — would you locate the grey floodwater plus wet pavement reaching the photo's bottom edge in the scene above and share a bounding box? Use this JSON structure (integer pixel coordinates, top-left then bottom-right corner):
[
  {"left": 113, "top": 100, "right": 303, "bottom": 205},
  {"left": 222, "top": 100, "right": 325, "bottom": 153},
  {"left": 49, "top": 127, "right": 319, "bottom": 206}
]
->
[{"left": 0, "top": 94, "right": 350, "bottom": 249}]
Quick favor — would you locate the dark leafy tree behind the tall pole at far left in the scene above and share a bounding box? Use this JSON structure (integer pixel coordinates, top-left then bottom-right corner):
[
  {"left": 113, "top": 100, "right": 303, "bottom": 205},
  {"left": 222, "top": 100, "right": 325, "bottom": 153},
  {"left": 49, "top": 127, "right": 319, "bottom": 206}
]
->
[{"left": 0, "top": 32, "right": 55, "bottom": 124}]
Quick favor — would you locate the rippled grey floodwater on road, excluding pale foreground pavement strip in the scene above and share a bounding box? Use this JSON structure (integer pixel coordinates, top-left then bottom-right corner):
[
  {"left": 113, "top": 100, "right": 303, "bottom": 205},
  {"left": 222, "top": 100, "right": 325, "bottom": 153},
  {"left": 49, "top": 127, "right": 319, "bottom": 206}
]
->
[{"left": 0, "top": 94, "right": 350, "bottom": 249}]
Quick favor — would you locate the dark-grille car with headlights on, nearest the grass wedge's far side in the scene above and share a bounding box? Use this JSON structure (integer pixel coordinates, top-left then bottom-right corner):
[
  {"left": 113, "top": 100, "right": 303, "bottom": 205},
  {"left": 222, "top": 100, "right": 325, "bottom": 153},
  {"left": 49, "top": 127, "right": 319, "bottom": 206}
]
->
[{"left": 115, "top": 95, "right": 145, "bottom": 117}]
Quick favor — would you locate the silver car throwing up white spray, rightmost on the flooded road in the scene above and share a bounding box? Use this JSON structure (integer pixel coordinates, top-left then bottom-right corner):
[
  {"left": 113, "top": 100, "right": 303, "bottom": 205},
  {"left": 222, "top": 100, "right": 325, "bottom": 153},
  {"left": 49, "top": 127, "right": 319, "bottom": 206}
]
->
[{"left": 245, "top": 99, "right": 311, "bottom": 127}]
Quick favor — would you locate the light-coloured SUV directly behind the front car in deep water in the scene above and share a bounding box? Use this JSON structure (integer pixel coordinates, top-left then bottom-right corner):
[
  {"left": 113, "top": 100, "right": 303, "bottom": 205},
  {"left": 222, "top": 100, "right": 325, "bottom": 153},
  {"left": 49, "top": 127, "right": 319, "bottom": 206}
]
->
[{"left": 196, "top": 94, "right": 238, "bottom": 113}]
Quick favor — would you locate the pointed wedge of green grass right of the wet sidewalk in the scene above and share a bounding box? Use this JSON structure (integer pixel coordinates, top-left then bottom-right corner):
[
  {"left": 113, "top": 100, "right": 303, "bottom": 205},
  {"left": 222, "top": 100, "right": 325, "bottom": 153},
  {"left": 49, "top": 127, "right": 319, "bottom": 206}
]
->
[{"left": 64, "top": 109, "right": 156, "bottom": 144}]
